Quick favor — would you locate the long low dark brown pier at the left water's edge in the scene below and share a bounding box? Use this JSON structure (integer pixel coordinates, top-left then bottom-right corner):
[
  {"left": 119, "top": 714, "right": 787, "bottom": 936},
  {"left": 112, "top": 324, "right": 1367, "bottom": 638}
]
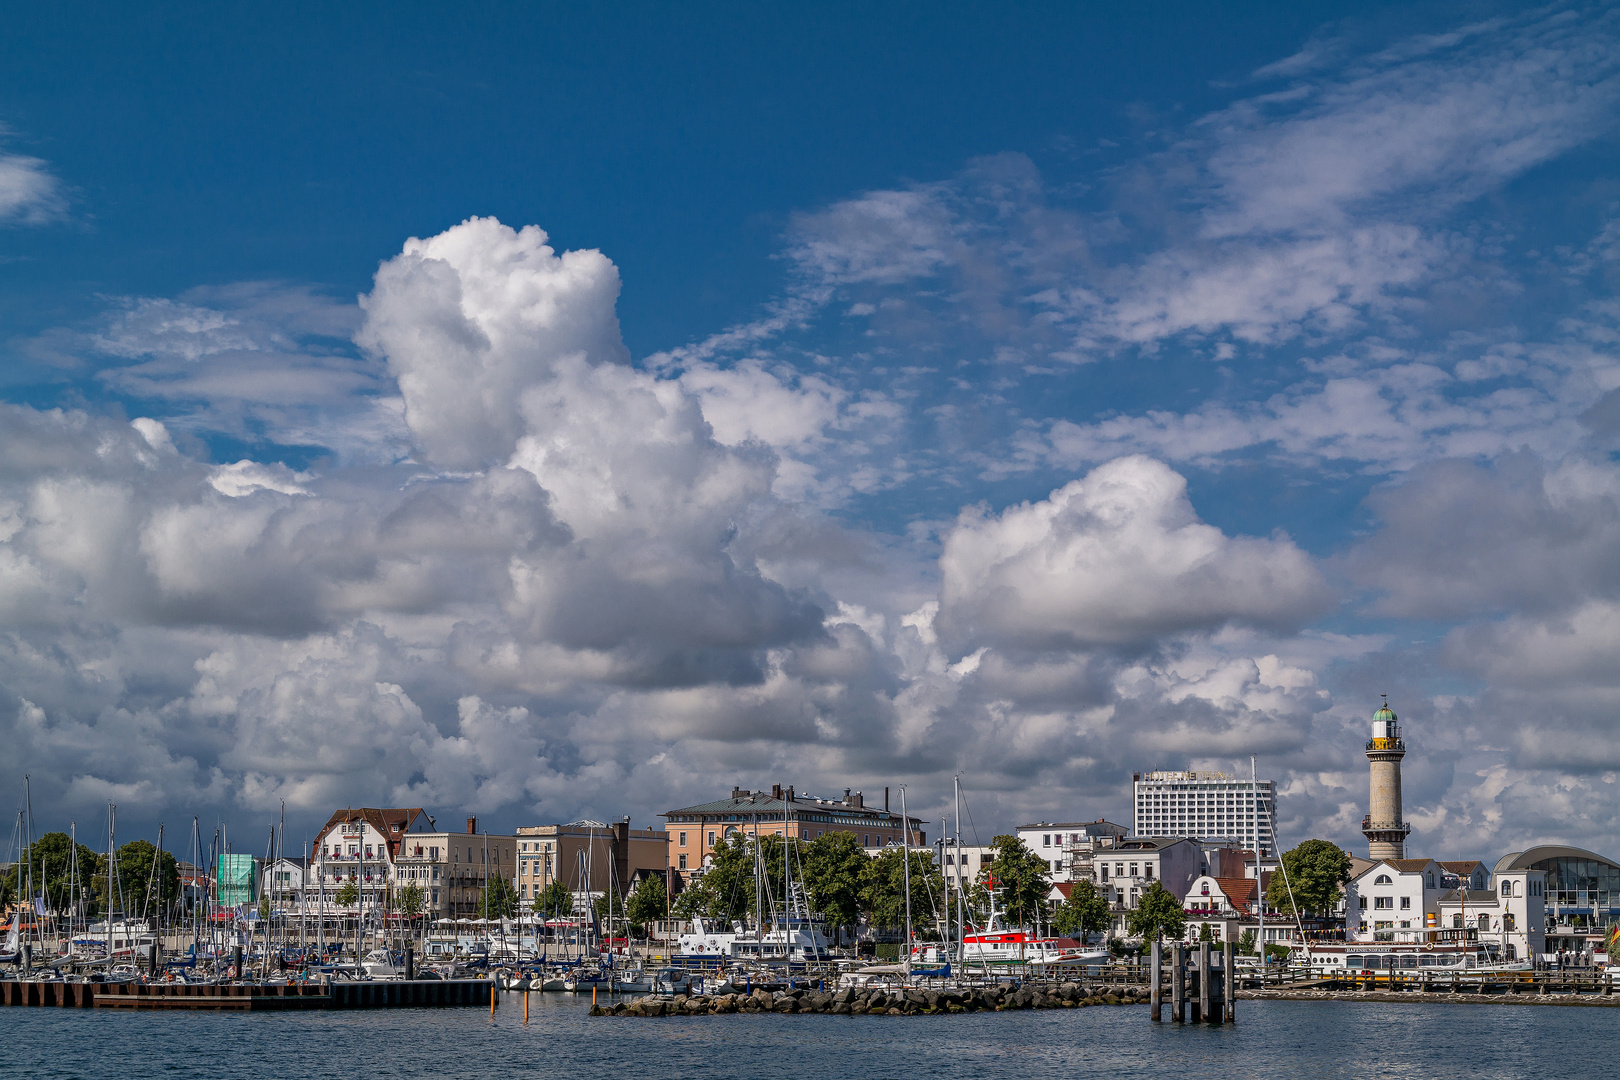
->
[{"left": 0, "top": 980, "right": 494, "bottom": 1012}]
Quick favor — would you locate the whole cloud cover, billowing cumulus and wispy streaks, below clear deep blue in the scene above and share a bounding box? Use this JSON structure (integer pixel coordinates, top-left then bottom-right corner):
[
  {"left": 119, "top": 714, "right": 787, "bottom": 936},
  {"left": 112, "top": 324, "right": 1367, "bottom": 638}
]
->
[{"left": 9, "top": 4, "right": 1620, "bottom": 857}]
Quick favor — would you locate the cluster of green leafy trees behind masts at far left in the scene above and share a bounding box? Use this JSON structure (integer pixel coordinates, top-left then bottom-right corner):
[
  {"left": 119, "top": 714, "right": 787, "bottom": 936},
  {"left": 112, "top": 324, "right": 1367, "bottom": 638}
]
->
[{"left": 0, "top": 832, "right": 180, "bottom": 918}]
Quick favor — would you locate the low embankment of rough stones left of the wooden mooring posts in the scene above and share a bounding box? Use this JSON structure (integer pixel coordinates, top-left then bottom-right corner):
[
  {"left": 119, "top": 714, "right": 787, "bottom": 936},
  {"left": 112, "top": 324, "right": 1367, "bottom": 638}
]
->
[{"left": 591, "top": 981, "right": 1147, "bottom": 1017}]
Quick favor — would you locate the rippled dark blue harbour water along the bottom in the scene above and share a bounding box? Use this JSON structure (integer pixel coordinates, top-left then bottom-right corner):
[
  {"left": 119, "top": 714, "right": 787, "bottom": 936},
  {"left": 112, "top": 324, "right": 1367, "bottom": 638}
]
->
[{"left": 0, "top": 994, "right": 1620, "bottom": 1080}]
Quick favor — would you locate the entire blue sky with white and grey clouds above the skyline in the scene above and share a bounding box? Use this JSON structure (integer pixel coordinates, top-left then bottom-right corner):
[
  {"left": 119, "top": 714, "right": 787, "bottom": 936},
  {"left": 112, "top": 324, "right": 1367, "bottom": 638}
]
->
[{"left": 0, "top": 3, "right": 1620, "bottom": 860}]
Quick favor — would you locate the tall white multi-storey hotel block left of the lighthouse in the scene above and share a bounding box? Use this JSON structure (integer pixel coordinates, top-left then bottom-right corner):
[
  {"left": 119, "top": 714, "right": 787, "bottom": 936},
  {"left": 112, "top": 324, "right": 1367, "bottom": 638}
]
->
[{"left": 1131, "top": 772, "right": 1277, "bottom": 858}]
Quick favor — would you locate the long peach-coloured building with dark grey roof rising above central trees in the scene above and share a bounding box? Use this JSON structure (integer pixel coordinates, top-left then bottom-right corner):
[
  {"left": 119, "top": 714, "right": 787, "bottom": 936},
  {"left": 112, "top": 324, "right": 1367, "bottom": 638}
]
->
[{"left": 661, "top": 784, "right": 928, "bottom": 892}]
